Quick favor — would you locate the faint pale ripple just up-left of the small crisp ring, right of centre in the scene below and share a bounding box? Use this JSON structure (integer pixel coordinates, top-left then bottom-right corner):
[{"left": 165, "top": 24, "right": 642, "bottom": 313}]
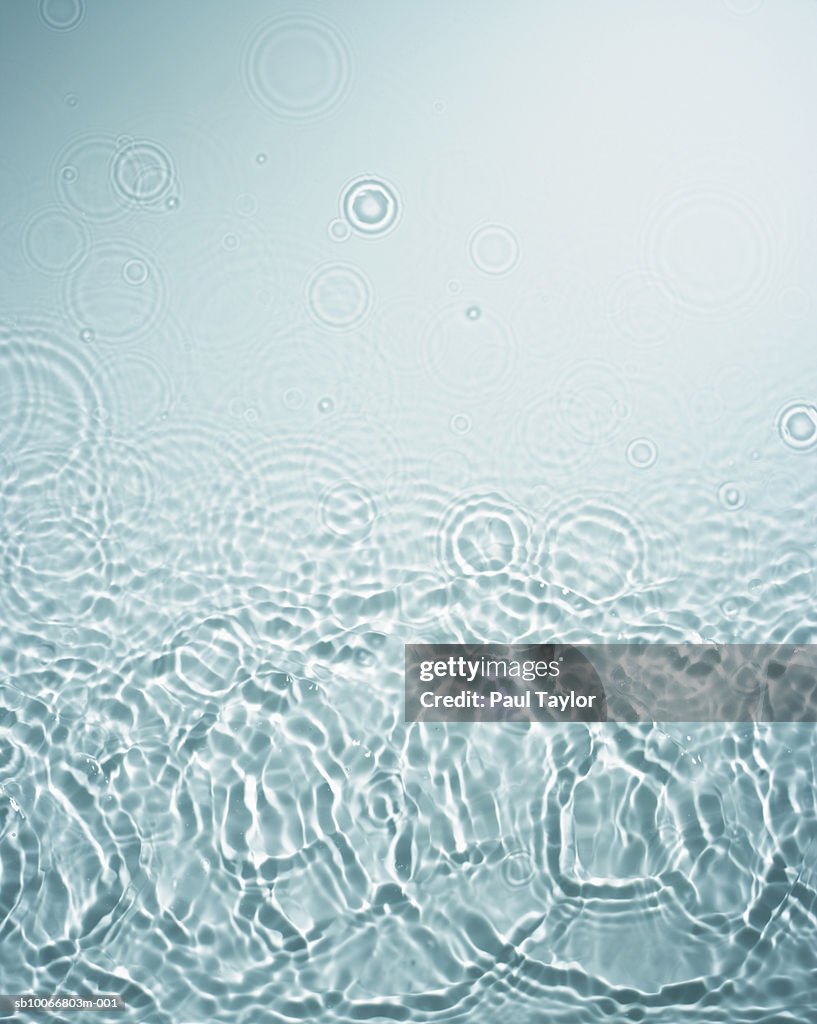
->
[{"left": 555, "top": 361, "right": 630, "bottom": 445}]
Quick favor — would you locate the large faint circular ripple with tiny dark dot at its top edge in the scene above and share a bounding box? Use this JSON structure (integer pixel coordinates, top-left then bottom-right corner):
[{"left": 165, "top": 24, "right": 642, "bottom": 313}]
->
[{"left": 426, "top": 305, "right": 514, "bottom": 400}]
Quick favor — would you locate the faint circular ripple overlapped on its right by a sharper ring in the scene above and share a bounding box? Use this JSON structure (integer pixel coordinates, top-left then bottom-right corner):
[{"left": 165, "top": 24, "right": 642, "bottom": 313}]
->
[{"left": 53, "top": 134, "right": 123, "bottom": 222}]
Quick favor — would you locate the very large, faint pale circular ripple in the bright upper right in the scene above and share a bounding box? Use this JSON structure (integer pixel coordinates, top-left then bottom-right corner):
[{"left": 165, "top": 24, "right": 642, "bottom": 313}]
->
[{"left": 646, "top": 189, "right": 772, "bottom": 317}]
